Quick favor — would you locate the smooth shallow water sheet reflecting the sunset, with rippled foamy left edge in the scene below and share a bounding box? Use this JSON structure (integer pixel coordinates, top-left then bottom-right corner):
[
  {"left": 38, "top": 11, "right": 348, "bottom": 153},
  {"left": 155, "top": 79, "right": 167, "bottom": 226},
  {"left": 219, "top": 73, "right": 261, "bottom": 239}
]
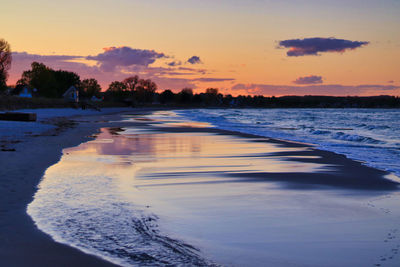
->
[{"left": 28, "top": 112, "right": 400, "bottom": 266}]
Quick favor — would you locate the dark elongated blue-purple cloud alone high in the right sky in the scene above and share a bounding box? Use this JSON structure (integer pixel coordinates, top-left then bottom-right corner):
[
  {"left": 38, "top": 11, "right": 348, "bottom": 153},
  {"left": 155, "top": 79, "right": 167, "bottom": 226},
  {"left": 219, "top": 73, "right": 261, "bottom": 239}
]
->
[{"left": 279, "top": 37, "right": 369, "bottom": 57}]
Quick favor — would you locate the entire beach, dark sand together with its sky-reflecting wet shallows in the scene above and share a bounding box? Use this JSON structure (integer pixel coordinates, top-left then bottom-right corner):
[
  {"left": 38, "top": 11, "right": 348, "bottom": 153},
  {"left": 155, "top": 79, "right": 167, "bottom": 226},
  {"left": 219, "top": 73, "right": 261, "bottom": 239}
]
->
[{"left": 0, "top": 110, "right": 400, "bottom": 266}]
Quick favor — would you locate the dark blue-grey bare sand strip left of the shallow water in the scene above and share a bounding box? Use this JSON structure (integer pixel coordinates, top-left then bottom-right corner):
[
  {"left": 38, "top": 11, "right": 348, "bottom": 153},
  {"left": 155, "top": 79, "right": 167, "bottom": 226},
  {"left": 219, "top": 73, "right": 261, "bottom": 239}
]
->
[{"left": 0, "top": 109, "right": 144, "bottom": 266}]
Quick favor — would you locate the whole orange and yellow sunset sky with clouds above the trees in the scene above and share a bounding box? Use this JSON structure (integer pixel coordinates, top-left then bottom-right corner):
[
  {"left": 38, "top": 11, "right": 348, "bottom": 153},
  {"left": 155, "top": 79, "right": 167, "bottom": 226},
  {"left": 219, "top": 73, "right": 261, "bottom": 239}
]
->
[{"left": 0, "top": 0, "right": 400, "bottom": 96}]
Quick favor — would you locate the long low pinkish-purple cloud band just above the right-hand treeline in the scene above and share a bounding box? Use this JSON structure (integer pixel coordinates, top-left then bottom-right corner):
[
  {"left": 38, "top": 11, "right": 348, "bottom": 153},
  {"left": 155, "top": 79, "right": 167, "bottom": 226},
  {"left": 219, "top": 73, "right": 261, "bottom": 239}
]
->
[{"left": 231, "top": 83, "right": 400, "bottom": 96}]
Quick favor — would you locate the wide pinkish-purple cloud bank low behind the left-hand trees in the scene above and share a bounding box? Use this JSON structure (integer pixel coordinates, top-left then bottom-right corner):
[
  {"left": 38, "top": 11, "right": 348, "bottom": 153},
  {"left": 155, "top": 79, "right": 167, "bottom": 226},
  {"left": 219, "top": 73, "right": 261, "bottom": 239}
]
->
[{"left": 8, "top": 49, "right": 207, "bottom": 90}]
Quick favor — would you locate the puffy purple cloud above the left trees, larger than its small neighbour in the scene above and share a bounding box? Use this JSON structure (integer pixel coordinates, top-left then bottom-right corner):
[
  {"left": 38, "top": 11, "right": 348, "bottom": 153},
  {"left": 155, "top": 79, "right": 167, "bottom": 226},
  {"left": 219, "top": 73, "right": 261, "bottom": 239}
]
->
[{"left": 86, "top": 46, "right": 167, "bottom": 72}]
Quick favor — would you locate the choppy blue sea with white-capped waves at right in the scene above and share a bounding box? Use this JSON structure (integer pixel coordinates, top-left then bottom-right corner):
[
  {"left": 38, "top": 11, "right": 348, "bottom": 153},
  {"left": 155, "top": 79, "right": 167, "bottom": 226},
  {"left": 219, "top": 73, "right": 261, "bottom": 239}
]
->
[{"left": 177, "top": 109, "right": 400, "bottom": 176}]
